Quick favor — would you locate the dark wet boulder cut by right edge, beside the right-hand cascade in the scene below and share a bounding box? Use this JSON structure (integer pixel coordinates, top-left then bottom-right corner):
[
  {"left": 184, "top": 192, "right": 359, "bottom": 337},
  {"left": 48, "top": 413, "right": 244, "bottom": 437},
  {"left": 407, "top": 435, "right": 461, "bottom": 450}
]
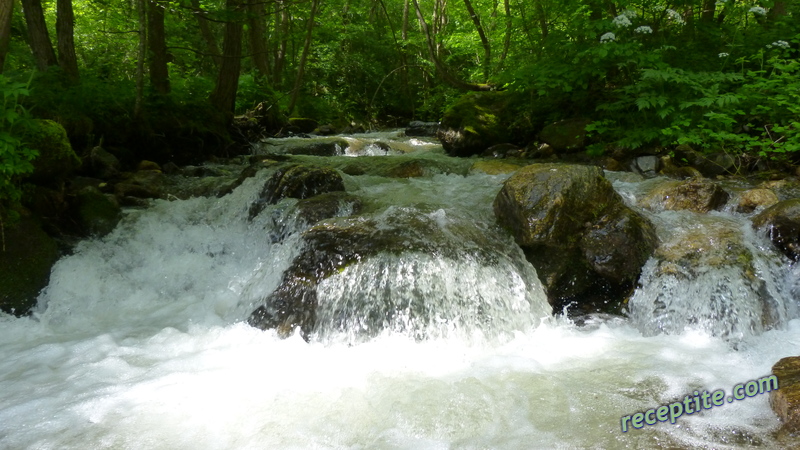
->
[{"left": 753, "top": 198, "right": 800, "bottom": 261}]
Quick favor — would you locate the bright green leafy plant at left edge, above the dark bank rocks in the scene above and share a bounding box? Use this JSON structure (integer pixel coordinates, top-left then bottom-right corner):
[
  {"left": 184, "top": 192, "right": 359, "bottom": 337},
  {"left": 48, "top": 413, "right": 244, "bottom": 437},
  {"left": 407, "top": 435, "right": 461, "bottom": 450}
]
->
[{"left": 0, "top": 75, "right": 38, "bottom": 220}]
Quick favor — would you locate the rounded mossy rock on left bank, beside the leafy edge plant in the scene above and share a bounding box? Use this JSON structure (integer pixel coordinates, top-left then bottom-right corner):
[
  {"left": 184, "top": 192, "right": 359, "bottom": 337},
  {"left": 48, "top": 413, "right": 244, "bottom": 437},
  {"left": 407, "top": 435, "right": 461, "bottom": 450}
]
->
[{"left": 23, "top": 120, "right": 81, "bottom": 184}]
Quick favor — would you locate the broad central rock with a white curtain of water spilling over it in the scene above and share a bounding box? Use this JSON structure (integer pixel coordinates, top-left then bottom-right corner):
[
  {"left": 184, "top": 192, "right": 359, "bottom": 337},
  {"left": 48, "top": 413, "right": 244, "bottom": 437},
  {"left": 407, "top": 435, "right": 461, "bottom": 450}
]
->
[{"left": 248, "top": 207, "right": 535, "bottom": 339}]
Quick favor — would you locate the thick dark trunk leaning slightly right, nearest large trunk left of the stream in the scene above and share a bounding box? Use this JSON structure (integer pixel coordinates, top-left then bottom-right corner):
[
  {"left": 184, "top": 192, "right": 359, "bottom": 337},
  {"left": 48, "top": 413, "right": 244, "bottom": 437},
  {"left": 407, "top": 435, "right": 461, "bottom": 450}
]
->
[{"left": 210, "top": 0, "right": 242, "bottom": 114}]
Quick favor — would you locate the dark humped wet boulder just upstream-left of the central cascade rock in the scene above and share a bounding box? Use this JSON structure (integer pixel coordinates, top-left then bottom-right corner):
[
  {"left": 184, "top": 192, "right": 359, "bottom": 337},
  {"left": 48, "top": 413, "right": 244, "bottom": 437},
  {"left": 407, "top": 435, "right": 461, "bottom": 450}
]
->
[{"left": 250, "top": 165, "right": 345, "bottom": 218}]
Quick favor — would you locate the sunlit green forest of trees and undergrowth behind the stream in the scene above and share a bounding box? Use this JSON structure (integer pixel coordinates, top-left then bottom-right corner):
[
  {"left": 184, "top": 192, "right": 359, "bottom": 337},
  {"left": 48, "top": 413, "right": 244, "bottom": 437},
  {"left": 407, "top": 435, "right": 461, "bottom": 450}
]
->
[{"left": 0, "top": 0, "right": 800, "bottom": 221}]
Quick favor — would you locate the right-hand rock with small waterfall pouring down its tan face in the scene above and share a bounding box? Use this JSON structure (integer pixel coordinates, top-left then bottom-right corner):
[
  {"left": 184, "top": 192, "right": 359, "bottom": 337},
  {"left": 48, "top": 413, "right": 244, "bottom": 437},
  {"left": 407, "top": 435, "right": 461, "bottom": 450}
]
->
[{"left": 628, "top": 213, "right": 787, "bottom": 340}]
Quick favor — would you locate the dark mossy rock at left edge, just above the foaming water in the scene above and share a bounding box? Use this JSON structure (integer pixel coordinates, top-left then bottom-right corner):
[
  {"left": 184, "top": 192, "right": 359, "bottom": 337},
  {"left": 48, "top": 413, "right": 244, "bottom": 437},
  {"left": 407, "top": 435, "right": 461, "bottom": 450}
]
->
[{"left": 0, "top": 217, "right": 59, "bottom": 316}]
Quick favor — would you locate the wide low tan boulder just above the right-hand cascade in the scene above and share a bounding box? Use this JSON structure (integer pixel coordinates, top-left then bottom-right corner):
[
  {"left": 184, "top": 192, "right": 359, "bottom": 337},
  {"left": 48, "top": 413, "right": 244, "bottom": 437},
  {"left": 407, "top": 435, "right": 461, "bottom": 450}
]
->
[{"left": 639, "top": 179, "right": 730, "bottom": 213}]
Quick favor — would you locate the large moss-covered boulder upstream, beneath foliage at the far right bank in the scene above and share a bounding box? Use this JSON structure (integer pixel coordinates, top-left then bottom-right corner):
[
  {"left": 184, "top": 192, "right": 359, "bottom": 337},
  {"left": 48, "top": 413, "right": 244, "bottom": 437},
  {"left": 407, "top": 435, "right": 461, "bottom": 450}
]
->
[{"left": 437, "top": 92, "right": 525, "bottom": 156}]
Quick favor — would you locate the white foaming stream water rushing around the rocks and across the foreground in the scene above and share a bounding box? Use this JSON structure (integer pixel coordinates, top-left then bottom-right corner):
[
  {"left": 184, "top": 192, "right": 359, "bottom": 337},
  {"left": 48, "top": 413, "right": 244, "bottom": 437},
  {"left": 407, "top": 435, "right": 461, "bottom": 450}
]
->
[{"left": 0, "top": 135, "right": 800, "bottom": 449}]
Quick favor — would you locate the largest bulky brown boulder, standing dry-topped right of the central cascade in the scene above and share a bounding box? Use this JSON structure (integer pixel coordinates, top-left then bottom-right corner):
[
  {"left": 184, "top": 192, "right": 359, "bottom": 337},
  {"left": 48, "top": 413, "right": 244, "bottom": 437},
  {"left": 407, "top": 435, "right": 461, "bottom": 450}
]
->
[{"left": 494, "top": 164, "right": 657, "bottom": 313}]
